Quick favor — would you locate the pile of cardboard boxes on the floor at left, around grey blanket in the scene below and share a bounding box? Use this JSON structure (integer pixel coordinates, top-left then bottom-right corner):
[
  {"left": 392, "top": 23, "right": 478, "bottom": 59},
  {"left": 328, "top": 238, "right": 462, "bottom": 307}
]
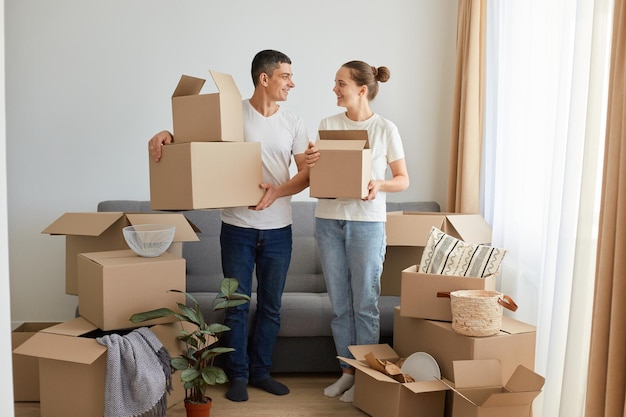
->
[{"left": 13, "top": 212, "right": 198, "bottom": 417}]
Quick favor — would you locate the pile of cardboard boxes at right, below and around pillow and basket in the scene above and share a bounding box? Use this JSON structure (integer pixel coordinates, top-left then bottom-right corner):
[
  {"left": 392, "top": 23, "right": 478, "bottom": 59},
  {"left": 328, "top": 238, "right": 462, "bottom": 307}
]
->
[{"left": 340, "top": 212, "right": 544, "bottom": 417}]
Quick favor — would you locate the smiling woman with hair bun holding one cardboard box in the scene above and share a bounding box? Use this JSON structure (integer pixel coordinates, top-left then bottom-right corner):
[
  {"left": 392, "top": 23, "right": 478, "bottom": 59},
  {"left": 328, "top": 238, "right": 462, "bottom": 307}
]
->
[{"left": 306, "top": 61, "right": 409, "bottom": 402}]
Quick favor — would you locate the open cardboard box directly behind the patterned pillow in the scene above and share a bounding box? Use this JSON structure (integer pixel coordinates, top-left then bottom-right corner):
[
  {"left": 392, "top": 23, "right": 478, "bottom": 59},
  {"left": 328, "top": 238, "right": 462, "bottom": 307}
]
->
[{"left": 381, "top": 211, "right": 491, "bottom": 296}]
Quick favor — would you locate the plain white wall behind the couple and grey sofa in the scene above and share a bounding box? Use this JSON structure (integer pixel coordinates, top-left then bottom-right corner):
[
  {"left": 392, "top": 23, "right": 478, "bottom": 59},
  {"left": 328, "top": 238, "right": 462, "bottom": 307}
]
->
[{"left": 5, "top": 0, "right": 457, "bottom": 322}]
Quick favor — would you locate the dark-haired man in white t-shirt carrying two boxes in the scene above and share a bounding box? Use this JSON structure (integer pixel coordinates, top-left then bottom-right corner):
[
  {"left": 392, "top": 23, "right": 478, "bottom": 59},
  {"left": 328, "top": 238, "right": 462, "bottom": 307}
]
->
[{"left": 149, "top": 50, "right": 309, "bottom": 401}]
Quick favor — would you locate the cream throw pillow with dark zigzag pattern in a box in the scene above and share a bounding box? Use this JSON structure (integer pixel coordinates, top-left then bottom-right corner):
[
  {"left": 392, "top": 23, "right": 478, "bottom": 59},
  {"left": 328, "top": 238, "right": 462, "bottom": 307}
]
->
[{"left": 419, "top": 227, "right": 507, "bottom": 278}]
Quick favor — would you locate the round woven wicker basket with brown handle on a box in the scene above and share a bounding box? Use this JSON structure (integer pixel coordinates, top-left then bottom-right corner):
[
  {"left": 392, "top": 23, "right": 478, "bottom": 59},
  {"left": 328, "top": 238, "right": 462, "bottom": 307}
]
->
[{"left": 438, "top": 290, "right": 517, "bottom": 336}]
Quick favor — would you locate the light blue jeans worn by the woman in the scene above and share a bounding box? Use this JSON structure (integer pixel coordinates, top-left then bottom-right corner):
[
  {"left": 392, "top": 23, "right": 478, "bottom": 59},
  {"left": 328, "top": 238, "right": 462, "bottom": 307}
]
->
[{"left": 315, "top": 218, "right": 386, "bottom": 367}]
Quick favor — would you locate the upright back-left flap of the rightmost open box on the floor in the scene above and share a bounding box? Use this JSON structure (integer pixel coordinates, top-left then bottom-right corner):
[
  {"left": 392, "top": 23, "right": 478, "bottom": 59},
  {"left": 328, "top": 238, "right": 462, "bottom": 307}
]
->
[{"left": 452, "top": 359, "right": 502, "bottom": 388}]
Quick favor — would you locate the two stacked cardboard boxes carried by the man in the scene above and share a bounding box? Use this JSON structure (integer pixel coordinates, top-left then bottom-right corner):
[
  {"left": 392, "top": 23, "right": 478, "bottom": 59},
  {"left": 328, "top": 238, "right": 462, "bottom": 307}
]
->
[{"left": 150, "top": 71, "right": 263, "bottom": 210}]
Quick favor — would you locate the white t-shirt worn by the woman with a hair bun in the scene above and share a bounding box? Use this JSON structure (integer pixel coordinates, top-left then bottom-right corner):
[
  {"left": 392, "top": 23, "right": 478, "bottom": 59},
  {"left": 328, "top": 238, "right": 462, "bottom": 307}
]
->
[{"left": 312, "top": 112, "right": 404, "bottom": 222}]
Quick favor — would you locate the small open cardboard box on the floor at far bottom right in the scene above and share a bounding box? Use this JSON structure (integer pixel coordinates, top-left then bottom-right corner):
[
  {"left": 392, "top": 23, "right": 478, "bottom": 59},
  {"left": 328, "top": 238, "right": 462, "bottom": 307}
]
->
[{"left": 450, "top": 359, "right": 545, "bottom": 417}]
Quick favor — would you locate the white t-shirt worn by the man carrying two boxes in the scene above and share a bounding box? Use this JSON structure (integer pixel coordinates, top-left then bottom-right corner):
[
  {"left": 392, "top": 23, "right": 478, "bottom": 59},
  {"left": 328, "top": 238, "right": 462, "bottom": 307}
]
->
[{"left": 222, "top": 99, "right": 309, "bottom": 230}]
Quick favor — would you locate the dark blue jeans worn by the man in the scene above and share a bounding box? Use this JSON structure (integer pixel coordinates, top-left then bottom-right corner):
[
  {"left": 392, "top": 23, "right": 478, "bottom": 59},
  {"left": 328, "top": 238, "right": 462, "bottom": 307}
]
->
[{"left": 220, "top": 223, "right": 292, "bottom": 382}]
